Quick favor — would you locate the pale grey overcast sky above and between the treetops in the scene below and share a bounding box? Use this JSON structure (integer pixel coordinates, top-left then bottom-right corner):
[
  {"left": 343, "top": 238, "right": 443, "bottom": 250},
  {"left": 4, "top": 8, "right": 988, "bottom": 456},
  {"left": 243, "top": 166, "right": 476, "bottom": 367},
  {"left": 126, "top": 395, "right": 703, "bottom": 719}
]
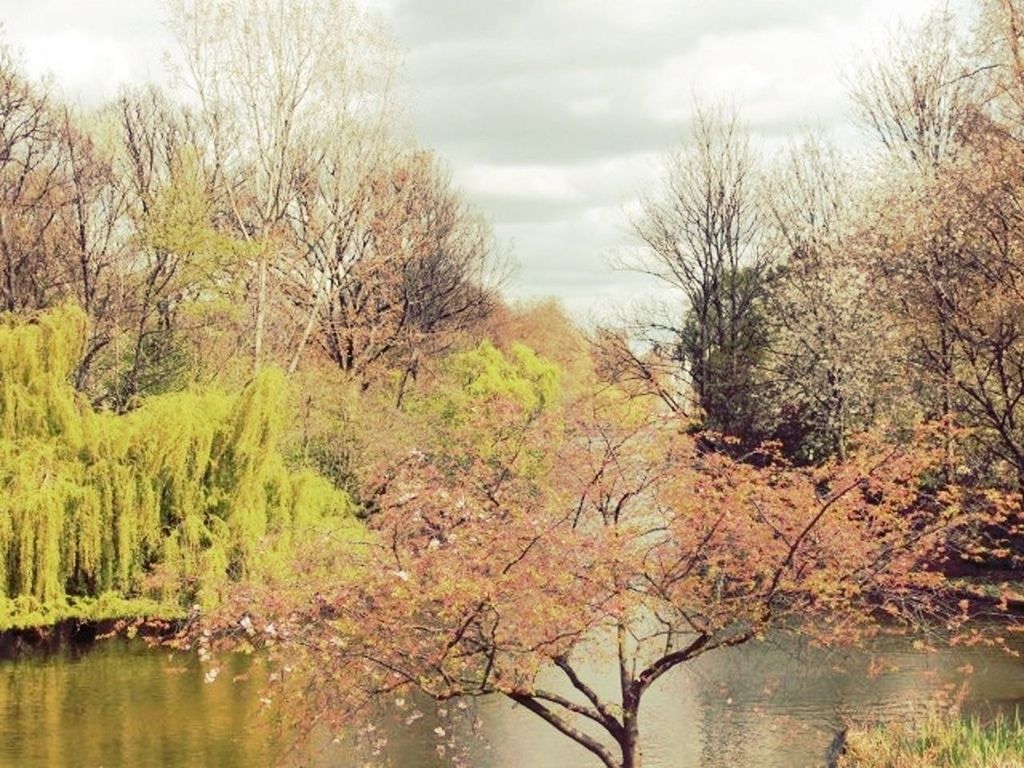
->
[{"left": 0, "top": 0, "right": 932, "bottom": 319}]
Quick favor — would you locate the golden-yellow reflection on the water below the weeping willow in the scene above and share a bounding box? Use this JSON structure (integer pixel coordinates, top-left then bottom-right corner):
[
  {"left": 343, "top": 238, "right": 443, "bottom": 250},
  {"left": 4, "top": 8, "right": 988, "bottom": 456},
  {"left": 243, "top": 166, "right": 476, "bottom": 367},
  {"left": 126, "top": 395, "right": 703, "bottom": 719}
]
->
[{"left": 0, "top": 642, "right": 272, "bottom": 768}]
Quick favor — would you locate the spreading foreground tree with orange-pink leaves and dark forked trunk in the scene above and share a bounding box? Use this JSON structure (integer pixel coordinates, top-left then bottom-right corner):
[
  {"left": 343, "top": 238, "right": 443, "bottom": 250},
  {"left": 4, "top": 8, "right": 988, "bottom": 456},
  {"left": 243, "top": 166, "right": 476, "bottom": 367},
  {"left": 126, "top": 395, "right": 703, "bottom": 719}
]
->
[{"left": 197, "top": 376, "right": 987, "bottom": 768}]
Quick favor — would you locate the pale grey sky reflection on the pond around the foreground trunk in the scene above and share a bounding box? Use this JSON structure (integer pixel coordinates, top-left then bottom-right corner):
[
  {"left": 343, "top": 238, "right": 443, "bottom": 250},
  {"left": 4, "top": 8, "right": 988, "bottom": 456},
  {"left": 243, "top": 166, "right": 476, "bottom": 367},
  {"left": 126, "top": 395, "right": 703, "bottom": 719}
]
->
[{"left": 460, "top": 638, "right": 1024, "bottom": 768}]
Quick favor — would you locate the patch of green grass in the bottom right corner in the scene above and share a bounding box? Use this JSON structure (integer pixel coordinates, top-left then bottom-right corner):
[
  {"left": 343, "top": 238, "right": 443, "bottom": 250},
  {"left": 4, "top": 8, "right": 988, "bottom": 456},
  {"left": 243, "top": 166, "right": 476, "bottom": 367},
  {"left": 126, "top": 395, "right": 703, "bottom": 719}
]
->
[{"left": 840, "top": 715, "right": 1024, "bottom": 768}]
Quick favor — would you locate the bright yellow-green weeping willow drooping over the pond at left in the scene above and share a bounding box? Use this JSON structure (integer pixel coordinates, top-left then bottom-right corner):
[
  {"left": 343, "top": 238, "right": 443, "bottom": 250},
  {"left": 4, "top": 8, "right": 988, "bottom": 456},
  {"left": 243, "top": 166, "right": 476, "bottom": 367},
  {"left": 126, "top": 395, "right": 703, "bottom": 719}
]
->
[{"left": 0, "top": 306, "right": 351, "bottom": 622}]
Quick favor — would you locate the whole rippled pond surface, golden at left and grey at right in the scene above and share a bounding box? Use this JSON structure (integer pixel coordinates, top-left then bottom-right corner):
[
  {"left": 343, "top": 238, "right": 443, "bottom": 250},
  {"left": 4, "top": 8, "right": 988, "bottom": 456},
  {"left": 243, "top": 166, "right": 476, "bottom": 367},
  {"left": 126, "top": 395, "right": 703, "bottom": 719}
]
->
[{"left": 0, "top": 639, "right": 1024, "bottom": 768}]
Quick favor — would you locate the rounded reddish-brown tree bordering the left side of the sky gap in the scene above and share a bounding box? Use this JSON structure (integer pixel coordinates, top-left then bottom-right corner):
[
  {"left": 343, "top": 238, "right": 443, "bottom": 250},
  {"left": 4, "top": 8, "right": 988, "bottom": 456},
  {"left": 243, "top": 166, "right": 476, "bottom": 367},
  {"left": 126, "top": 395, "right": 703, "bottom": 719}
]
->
[{"left": 299, "top": 153, "right": 500, "bottom": 391}]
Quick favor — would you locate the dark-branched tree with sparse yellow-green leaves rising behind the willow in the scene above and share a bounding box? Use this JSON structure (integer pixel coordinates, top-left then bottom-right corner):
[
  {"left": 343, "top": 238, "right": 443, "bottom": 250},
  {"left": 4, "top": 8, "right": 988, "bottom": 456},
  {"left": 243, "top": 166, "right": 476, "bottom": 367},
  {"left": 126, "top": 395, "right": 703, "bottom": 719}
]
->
[{"left": 109, "top": 89, "right": 250, "bottom": 411}]
